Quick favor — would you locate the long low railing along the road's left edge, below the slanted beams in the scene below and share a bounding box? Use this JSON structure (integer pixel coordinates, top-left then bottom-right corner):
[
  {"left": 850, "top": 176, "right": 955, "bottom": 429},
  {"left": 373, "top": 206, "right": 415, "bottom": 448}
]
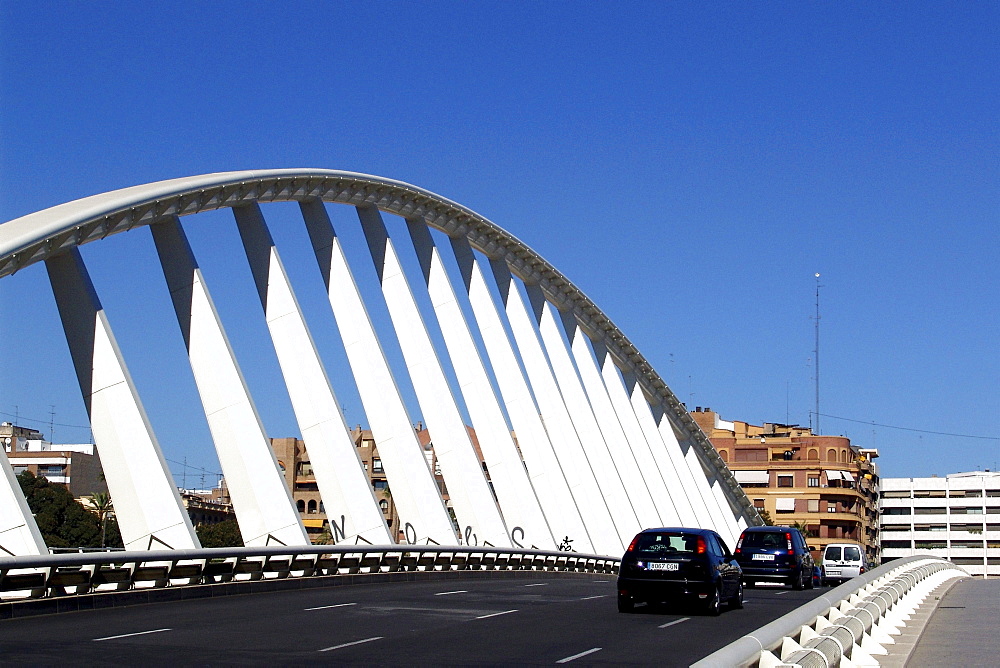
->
[{"left": 0, "top": 545, "right": 620, "bottom": 600}]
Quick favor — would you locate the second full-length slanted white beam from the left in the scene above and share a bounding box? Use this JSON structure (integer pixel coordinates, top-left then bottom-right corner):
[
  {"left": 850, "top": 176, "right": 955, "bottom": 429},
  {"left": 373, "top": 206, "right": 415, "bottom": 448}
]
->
[{"left": 149, "top": 218, "right": 309, "bottom": 546}]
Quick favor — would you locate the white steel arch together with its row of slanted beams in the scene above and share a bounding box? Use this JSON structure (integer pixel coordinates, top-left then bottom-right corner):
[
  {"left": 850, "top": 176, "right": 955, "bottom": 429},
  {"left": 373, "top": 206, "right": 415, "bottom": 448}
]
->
[{"left": 0, "top": 169, "right": 759, "bottom": 554}]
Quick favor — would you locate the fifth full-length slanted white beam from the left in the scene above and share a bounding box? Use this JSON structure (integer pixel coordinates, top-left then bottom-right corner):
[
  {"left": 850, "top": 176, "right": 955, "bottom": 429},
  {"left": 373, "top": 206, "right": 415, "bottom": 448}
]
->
[{"left": 357, "top": 206, "right": 511, "bottom": 547}]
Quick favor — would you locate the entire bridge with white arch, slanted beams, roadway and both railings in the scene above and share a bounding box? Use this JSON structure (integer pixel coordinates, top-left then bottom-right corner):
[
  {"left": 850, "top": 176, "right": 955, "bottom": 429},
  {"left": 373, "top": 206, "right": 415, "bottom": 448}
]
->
[{"left": 0, "top": 169, "right": 984, "bottom": 665}]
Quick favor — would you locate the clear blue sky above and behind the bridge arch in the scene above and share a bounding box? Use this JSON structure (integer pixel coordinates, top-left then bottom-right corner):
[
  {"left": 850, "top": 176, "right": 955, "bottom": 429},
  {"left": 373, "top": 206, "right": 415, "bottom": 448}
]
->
[{"left": 0, "top": 0, "right": 1000, "bottom": 485}]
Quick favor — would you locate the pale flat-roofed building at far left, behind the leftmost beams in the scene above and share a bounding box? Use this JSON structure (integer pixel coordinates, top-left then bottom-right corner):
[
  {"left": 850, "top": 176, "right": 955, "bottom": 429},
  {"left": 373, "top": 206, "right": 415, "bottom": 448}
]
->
[{"left": 0, "top": 422, "right": 108, "bottom": 498}]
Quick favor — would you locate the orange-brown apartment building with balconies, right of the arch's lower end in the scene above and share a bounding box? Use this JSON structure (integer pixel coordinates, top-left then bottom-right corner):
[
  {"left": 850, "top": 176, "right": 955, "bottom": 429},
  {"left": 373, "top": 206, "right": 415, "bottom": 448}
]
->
[{"left": 691, "top": 407, "right": 880, "bottom": 563}]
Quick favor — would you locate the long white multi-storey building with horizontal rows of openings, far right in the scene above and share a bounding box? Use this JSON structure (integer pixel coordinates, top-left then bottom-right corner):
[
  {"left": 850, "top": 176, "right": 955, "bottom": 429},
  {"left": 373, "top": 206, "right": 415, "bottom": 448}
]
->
[{"left": 880, "top": 471, "right": 1000, "bottom": 577}]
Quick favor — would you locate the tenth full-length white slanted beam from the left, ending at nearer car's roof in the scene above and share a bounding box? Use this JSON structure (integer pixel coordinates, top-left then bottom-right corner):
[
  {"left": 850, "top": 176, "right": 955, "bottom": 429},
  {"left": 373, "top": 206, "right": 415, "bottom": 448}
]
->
[{"left": 559, "top": 312, "right": 665, "bottom": 542}]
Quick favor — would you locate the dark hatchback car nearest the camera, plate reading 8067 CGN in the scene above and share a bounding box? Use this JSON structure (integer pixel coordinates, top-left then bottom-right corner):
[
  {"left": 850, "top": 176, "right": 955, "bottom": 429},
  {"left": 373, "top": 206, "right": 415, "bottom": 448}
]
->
[{"left": 618, "top": 528, "right": 743, "bottom": 615}]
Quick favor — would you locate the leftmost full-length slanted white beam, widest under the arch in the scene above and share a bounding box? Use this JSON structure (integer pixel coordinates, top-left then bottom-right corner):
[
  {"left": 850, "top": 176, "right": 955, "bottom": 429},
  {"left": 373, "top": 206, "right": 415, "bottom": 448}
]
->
[{"left": 45, "top": 248, "right": 201, "bottom": 550}]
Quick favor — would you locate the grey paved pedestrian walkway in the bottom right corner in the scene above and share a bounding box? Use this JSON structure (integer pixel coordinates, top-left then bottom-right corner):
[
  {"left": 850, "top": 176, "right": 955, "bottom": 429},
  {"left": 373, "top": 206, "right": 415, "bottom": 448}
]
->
[{"left": 876, "top": 578, "right": 1000, "bottom": 668}]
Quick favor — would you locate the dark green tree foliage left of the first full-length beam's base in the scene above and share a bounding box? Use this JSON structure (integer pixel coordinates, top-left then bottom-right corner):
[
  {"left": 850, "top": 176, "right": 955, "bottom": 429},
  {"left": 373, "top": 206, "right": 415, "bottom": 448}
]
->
[{"left": 17, "top": 471, "right": 123, "bottom": 547}]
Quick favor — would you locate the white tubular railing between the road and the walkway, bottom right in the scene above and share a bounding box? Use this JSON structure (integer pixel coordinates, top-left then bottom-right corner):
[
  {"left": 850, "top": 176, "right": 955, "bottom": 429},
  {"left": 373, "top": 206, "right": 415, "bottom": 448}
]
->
[{"left": 692, "top": 556, "right": 968, "bottom": 668}]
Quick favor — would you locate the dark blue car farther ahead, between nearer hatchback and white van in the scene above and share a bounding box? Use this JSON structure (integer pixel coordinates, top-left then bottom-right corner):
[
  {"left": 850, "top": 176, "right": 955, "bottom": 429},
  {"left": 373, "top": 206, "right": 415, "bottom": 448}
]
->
[{"left": 736, "top": 526, "right": 815, "bottom": 589}]
